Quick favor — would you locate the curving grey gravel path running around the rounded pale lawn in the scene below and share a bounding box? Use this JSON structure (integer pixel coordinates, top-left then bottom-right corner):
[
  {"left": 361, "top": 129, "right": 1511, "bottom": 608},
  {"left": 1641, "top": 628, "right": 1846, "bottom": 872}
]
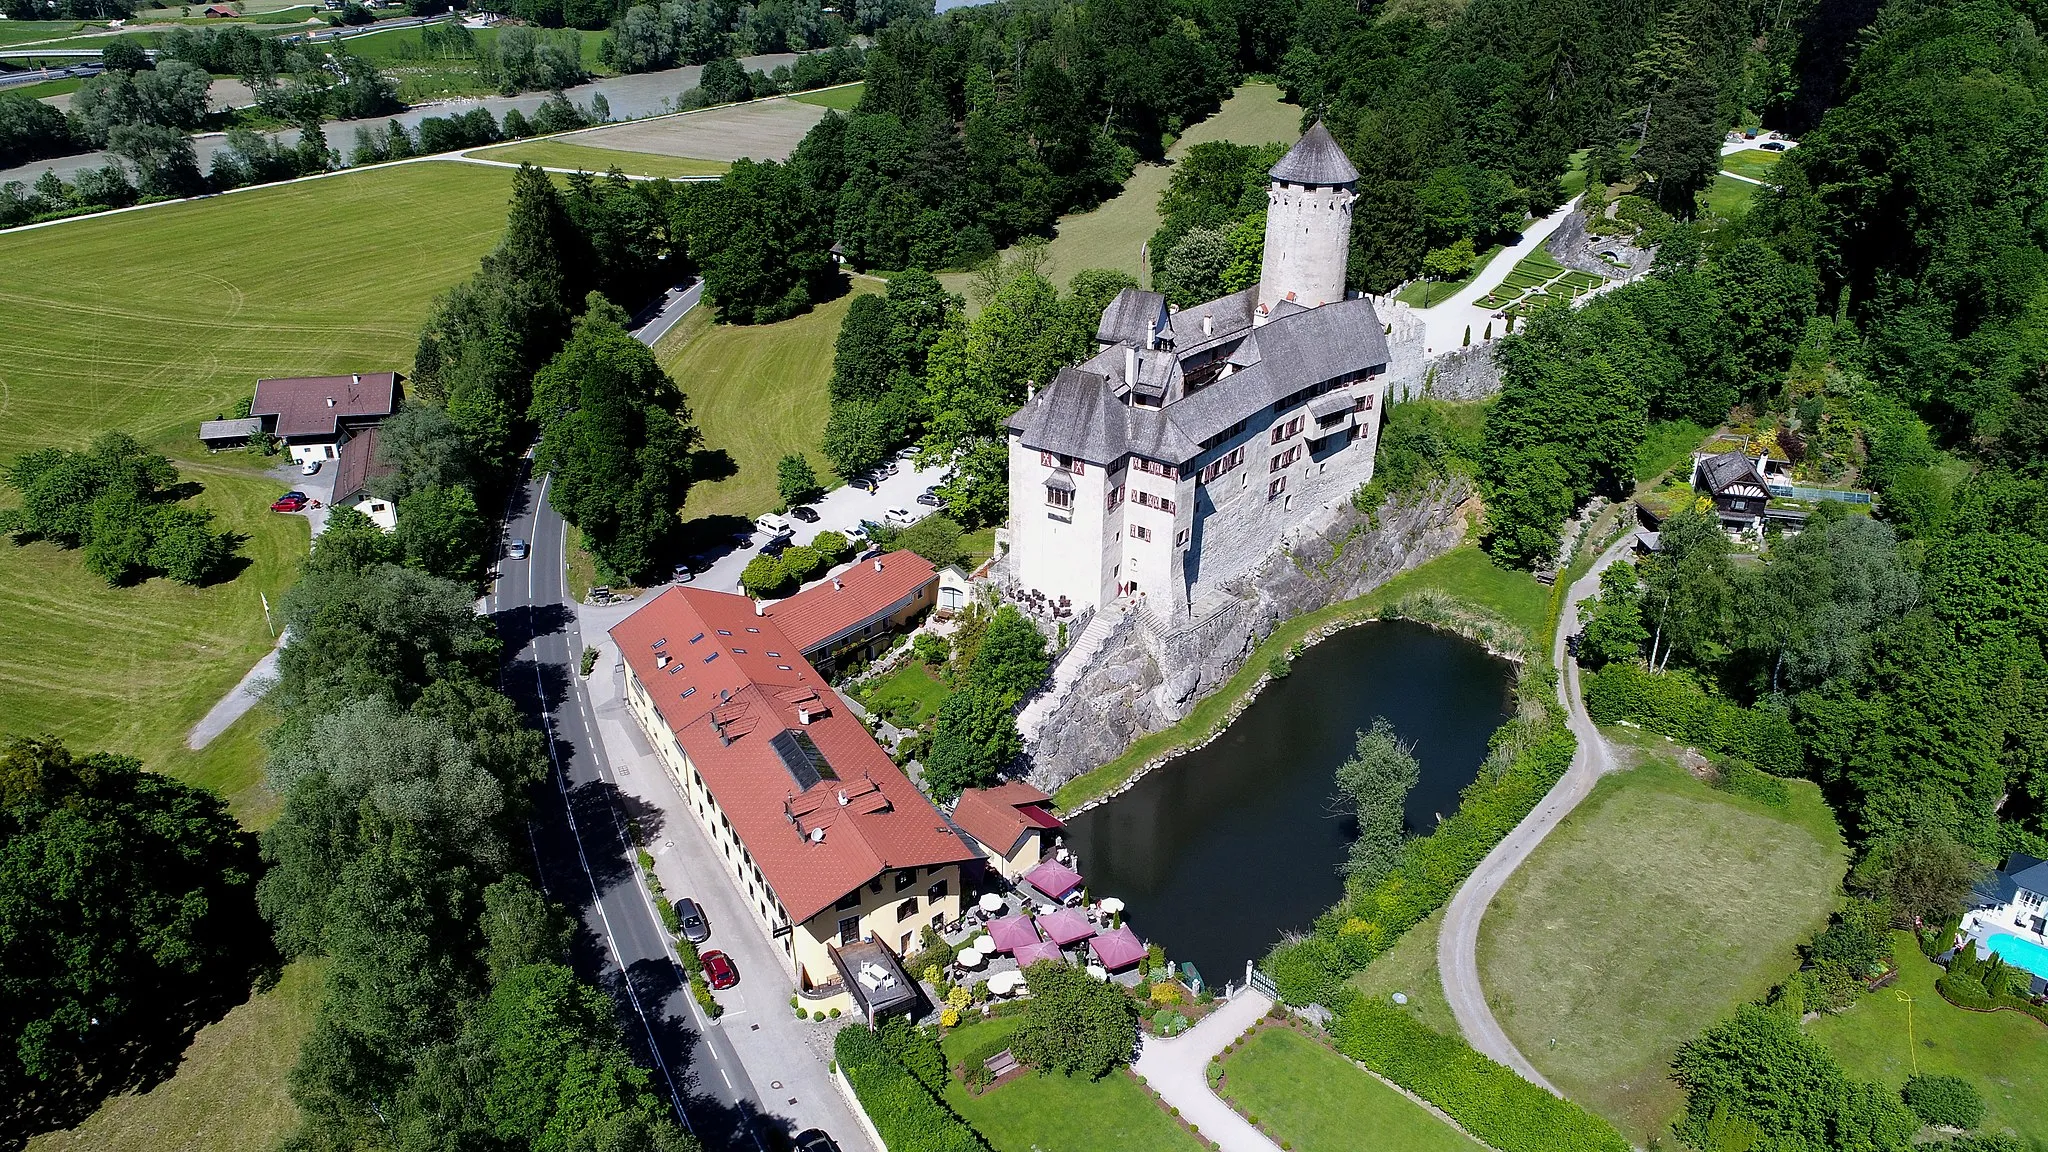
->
[{"left": 1436, "top": 531, "right": 1636, "bottom": 1097}]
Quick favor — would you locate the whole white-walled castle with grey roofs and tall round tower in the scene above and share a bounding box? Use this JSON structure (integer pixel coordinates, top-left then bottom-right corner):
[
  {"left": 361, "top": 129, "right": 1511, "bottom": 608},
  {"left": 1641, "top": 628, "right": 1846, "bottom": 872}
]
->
[{"left": 1008, "top": 123, "right": 1413, "bottom": 621}]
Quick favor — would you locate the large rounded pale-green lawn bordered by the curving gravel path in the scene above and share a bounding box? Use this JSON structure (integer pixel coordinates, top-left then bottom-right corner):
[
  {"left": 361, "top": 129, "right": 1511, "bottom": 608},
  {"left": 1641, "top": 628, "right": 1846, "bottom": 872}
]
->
[{"left": 1479, "top": 746, "right": 1845, "bottom": 1144}]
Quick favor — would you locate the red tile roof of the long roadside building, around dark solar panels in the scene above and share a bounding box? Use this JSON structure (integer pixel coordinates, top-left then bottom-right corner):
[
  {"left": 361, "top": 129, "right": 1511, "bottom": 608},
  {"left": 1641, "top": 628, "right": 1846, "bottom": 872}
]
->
[{"left": 612, "top": 588, "right": 975, "bottom": 922}]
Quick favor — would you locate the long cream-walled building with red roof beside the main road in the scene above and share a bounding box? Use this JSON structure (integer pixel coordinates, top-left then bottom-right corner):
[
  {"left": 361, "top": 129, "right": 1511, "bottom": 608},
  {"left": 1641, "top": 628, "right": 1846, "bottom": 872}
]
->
[{"left": 610, "top": 582, "right": 977, "bottom": 1009}]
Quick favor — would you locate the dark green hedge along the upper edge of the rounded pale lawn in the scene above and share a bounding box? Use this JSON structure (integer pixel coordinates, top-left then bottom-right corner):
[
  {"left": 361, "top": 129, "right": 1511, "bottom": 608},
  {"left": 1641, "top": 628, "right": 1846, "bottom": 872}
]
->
[{"left": 1585, "top": 664, "right": 1804, "bottom": 775}]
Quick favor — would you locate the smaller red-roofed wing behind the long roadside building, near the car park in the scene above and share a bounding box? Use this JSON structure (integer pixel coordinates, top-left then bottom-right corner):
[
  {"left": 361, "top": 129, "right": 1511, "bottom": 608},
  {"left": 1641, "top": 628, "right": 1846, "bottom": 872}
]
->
[{"left": 768, "top": 551, "right": 938, "bottom": 676}]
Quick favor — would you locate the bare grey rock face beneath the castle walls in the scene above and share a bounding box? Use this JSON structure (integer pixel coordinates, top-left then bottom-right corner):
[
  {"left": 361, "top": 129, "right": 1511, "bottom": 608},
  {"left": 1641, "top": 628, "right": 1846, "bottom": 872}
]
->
[{"left": 1026, "top": 482, "right": 1470, "bottom": 791}]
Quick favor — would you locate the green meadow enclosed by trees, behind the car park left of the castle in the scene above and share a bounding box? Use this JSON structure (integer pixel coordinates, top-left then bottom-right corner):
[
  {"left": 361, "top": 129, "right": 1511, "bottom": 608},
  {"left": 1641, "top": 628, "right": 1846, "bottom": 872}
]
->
[{"left": 655, "top": 279, "right": 881, "bottom": 519}]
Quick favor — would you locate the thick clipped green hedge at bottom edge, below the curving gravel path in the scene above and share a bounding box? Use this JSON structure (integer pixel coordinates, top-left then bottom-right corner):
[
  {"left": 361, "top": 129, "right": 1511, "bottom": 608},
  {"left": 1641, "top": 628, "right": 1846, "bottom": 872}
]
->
[{"left": 1331, "top": 998, "right": 1630, "bottom": 1152}]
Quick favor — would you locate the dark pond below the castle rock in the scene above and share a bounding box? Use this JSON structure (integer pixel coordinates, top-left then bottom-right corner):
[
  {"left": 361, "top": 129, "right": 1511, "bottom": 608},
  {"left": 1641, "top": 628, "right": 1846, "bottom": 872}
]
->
[{"left": 1067, "top": 621, "right": 1513, "bottom": 986}]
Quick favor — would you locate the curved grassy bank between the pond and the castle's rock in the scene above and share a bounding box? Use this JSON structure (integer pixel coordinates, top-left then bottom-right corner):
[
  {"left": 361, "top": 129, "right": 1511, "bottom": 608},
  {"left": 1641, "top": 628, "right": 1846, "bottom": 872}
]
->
[{"left": 1053, "top": 541, "right": 1550, "bottom": 818}]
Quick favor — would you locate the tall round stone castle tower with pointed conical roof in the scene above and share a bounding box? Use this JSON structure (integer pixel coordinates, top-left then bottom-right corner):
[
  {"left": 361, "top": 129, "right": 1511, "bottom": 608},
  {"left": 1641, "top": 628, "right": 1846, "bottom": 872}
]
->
[{"left": 1260, "top": 121, "right": 1358, "bottom": 316}]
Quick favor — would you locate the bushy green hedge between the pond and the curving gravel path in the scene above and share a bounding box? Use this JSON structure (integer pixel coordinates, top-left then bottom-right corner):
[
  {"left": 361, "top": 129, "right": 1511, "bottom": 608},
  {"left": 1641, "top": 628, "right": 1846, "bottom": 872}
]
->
[{"left": 1262, "top": 688, "right": 1579, "bottom": 1009}]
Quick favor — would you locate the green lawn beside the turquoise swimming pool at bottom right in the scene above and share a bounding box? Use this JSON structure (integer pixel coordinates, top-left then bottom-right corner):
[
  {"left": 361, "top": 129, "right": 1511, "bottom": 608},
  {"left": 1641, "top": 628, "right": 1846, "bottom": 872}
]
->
[{"left": 1806, "top": 933, "right": 2048, "bottom": 1148}]
